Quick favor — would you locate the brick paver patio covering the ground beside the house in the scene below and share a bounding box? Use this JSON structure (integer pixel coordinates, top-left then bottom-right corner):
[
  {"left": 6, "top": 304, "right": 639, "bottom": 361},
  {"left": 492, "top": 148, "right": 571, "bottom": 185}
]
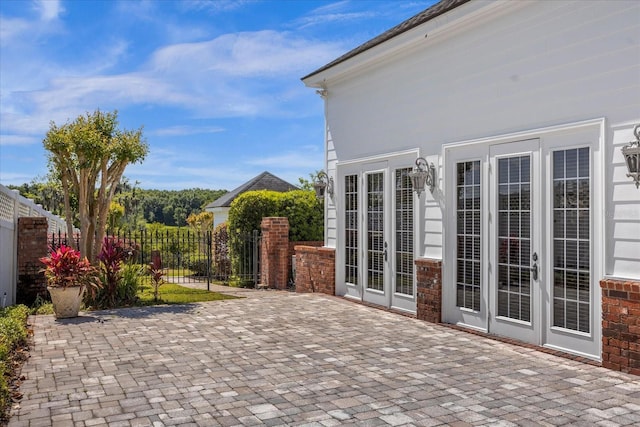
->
[{"left": 9, "top": 291, "right": 640, "bottom": 427}]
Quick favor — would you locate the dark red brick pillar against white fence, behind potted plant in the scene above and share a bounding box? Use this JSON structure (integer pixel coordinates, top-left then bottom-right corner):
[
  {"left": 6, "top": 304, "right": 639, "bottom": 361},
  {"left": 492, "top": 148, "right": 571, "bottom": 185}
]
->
[{"left": 16, "top": 217, "right": 49, "bottom": 305}]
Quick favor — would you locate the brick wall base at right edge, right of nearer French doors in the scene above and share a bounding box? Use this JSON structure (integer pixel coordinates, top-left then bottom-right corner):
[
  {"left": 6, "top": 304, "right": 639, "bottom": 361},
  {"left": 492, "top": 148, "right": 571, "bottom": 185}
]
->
[{"left": 600, "top": 279, "right": 640, "bottom": 375}]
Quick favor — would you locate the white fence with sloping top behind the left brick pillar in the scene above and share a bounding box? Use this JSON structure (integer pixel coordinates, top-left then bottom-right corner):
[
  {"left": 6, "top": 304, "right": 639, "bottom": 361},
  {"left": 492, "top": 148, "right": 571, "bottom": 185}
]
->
[{"left": 0, "top": 184, "right": 67, "bottom": 307}]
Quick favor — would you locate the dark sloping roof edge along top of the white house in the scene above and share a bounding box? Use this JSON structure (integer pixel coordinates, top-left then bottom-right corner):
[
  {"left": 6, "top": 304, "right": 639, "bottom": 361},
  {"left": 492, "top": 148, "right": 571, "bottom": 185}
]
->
[{"left": 302, "top": 0, "right": 470, "bottom": 80}]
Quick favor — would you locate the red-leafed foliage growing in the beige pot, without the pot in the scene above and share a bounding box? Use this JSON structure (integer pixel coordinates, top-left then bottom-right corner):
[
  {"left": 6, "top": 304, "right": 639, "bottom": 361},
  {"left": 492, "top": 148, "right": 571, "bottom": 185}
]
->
[{"left": 40, "top": 245, "right": 101, "bottom": 289}]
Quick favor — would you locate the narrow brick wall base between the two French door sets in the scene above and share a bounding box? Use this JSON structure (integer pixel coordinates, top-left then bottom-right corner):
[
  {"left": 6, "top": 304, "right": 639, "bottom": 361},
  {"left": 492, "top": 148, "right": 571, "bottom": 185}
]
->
[{"left": 415, "top": 258, "right": 442, "bottom": 323}]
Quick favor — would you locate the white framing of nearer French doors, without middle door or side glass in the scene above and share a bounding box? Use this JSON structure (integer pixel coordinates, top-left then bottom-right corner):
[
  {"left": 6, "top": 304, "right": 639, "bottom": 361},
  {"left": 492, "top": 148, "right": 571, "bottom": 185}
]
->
[{"left": 442, "top": 118, "right": 605, "bottom": 360}]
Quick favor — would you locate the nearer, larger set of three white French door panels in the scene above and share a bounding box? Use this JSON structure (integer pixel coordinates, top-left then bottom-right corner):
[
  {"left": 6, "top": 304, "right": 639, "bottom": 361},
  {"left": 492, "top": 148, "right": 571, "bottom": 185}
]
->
[{"left": 443, "top": 124, "right": 601, "bottom": 359}]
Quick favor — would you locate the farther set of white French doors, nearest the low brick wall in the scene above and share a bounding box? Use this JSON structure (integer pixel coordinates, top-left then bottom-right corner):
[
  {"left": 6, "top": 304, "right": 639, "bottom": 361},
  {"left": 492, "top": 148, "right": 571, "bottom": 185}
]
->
[{"left": 336, "top": 155, "right": 416, "bottom": 313}]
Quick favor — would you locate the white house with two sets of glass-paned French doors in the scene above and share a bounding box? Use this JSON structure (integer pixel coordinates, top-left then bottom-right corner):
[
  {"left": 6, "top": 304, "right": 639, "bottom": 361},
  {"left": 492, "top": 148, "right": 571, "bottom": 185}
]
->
[{"left": 302, "top": 0, "right": 640, "bottom": 368}]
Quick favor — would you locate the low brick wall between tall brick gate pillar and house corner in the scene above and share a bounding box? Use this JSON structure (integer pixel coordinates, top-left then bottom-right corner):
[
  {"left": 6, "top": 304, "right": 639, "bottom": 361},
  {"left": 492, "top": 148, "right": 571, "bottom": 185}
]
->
[{"left": 295, "top": 245, "right": 336, "bottom": 295}]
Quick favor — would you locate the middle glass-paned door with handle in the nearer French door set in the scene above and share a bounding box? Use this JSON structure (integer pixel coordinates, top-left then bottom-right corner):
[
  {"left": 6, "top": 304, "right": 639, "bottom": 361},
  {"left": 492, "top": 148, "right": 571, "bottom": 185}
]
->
[{"left": 489, "top": 140, "right": 542, "bottom": 344}]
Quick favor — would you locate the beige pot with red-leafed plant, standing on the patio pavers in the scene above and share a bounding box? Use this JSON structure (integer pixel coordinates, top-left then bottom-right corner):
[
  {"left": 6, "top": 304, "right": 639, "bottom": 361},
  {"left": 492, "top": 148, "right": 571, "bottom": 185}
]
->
[{"left": 40, "top": 245, "right": 101, "bottom": 319}]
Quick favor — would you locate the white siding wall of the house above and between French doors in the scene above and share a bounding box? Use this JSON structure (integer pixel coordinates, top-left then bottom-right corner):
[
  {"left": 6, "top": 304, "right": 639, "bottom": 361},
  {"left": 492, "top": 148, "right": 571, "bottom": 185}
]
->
[{"left": 316, "top": 0, "right": 640, "bottom": 278}]
